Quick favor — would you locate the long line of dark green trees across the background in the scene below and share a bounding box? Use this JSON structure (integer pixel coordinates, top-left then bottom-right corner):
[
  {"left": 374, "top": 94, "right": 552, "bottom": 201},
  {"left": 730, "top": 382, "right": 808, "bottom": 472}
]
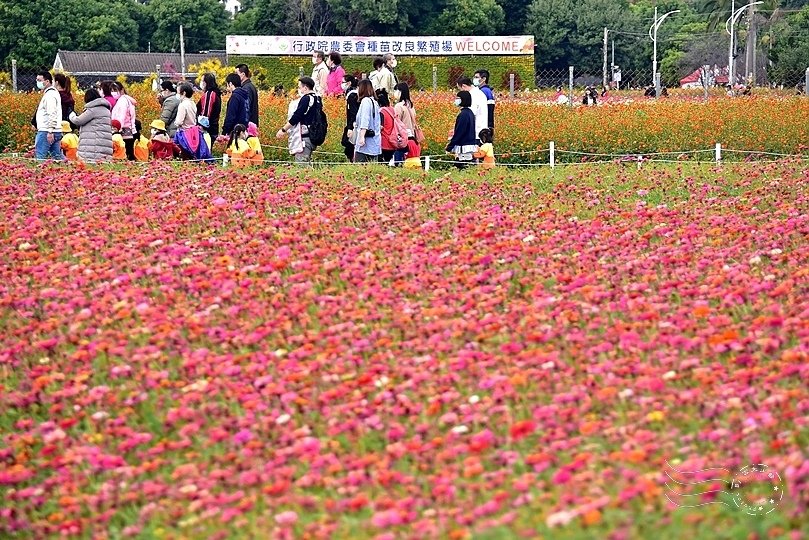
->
[{"left": 0, "top": 0, "right": 809, "bottom": 84}]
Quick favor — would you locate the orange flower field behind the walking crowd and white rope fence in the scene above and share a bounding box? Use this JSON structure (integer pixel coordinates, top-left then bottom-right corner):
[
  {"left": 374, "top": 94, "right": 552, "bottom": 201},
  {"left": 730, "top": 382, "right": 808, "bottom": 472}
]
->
[{"left": 0, "top": 87, "right": 809, "bottom": 163}]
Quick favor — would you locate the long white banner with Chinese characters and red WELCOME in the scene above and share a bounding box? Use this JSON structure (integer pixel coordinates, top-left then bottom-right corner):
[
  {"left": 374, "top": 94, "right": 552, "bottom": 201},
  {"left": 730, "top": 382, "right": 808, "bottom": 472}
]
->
[{"left": 227, "top": 36, "right": 534, "bottom": 56}]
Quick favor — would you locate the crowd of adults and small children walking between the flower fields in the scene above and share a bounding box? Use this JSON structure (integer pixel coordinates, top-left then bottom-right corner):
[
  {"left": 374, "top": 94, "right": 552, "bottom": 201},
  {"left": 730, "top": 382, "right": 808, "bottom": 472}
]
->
[{"left": 32, "top": 57, "right": 495, "bottom": 167}]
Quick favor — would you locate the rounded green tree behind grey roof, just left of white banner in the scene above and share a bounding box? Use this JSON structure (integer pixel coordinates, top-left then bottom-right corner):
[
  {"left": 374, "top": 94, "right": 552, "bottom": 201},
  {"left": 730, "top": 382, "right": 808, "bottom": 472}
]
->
[{"left": 146, "top": 0, "right": 230, "bottom": 51}]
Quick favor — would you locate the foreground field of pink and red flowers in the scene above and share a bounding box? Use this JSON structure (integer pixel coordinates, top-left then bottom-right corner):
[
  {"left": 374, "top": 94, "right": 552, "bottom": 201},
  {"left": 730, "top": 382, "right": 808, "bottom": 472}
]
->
[{"left": 0, "top": 161, "right": 809, "bottom": 540}]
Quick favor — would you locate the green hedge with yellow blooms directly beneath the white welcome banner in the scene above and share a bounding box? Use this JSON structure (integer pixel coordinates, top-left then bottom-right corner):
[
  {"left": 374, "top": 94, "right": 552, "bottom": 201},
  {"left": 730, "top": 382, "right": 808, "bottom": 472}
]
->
[{"left": 228, "top": 55, "right": 534, "bottom": 90}]
